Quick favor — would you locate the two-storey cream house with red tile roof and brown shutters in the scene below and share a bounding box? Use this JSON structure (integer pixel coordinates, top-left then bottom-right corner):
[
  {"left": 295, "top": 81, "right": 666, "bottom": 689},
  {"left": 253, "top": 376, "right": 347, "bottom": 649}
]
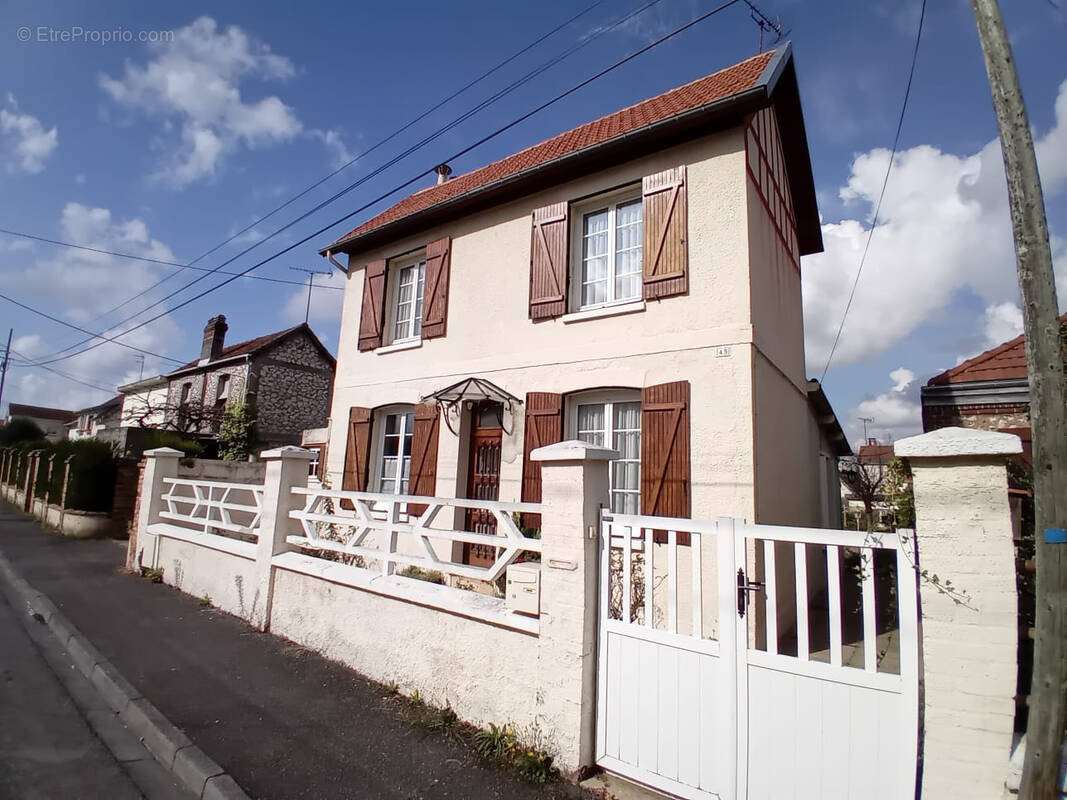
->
[{"left": 320, "top": 46, "right": 848, "bottom": 546}]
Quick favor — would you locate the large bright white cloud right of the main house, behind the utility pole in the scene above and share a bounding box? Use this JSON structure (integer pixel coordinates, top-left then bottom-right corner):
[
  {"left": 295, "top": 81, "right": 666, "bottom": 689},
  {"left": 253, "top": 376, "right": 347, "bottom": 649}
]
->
[{"left": 803, "top": 81, "right": 1067, "bottom": 369}]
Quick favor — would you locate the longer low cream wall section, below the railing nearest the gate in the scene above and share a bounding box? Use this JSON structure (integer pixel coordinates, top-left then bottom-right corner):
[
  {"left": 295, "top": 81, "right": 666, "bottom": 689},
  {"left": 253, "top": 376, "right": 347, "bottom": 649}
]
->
[{"left": 270, "top": 570, "right": 539, "bottom": 727}]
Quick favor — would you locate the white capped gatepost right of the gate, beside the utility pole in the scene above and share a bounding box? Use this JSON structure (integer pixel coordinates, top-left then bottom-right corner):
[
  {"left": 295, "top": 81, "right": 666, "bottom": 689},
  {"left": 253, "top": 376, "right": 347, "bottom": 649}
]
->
[{"left": 895, "top": 428, "right": 1022, "bottom": 800}]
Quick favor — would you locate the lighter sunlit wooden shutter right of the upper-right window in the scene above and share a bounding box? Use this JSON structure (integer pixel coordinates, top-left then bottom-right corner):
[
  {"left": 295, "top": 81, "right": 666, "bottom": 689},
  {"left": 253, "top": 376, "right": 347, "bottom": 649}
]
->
[{"left": 641, "top": 166, "right": 689, "bottom": 300}]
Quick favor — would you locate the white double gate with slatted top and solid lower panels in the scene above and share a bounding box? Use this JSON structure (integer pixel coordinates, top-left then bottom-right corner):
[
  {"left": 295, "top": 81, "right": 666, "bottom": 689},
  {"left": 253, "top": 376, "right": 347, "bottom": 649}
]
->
[{"left": 596, "top": 513, "right": 918, "bottom": 800}]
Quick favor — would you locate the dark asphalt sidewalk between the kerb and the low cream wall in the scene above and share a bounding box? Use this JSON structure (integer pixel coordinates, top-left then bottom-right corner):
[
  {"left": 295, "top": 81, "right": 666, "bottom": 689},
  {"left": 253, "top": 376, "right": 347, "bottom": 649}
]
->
[{"left": 0, "top": 507, "right": 573, "bottom": 800}]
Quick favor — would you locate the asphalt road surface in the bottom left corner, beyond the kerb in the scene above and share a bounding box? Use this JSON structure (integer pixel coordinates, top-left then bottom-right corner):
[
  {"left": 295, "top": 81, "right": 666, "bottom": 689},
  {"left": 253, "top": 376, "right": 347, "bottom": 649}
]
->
[{"left": 0, "top": 571, "right": 142, "bottom": 800}]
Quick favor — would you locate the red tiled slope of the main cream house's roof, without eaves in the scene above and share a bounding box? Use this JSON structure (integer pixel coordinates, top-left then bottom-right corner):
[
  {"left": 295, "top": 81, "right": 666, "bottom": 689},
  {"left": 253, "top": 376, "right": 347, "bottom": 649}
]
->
[{"left": 329, "top": 51, "right": 776, "bottom": 251}]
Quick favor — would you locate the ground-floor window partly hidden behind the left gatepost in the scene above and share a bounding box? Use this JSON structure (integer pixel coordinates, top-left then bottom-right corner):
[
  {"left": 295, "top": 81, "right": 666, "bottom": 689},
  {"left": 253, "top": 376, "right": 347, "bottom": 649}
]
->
[{"left": 571, "top": 391, "right": 641, "bottom": 514}]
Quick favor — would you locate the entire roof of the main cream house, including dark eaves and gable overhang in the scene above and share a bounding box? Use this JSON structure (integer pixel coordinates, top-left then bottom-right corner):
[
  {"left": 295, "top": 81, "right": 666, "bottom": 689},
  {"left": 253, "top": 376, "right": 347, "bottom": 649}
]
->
[{"left": 319, "top": 44, "right": 823, "bottom": 260}]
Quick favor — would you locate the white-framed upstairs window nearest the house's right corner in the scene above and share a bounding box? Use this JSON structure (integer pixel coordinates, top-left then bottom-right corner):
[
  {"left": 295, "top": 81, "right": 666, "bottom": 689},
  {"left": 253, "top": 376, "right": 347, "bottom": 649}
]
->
[{"left": 572, "top": 189, "right": 644, "bottom": 309}]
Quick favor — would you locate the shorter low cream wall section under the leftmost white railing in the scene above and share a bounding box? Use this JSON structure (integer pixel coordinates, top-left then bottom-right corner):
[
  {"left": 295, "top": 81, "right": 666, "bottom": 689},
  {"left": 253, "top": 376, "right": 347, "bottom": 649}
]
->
[{"left": 156, "top": 537, "right": 265, "bottom": 620}]
